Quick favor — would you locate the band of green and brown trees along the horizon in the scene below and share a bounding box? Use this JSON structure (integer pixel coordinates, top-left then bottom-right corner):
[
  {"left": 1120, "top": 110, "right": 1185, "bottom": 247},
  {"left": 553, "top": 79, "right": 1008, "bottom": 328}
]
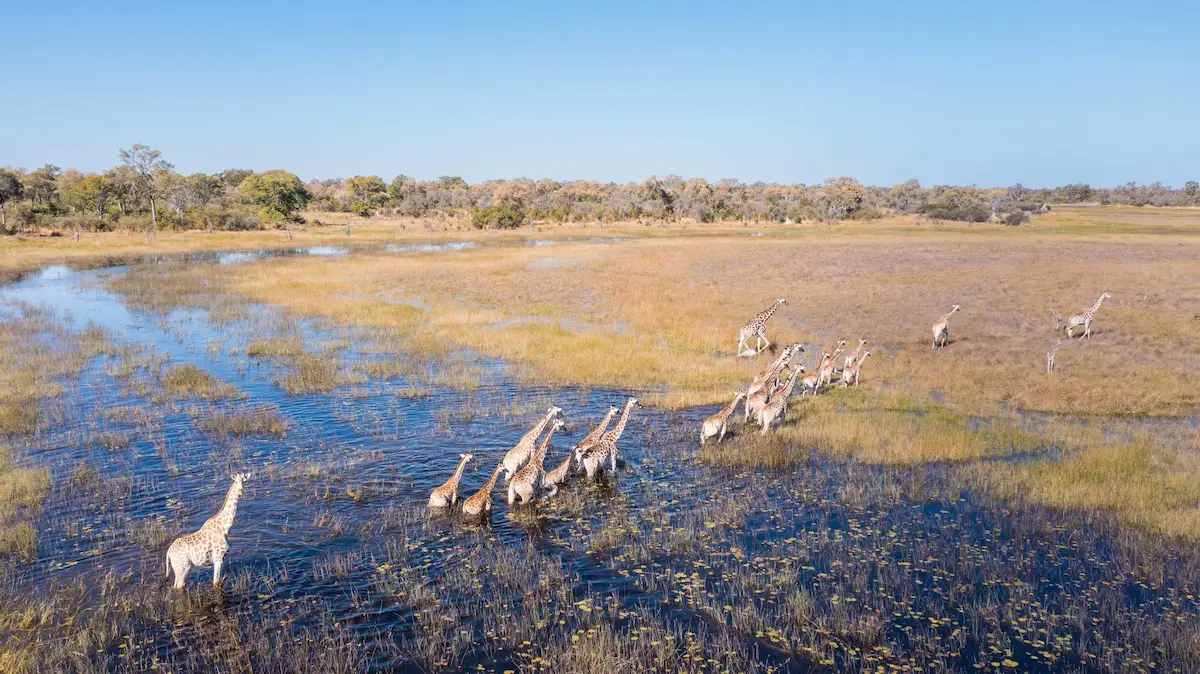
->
[{"left": 0, "top": 145, "right": 1200, "bottom": 233}]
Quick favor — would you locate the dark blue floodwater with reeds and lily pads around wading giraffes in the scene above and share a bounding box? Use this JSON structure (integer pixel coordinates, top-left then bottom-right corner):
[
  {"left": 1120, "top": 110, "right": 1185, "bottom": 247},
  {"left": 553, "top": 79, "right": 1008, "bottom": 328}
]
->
[{"left": 0, "top": 254, "right": 1200, "bottom": 672}]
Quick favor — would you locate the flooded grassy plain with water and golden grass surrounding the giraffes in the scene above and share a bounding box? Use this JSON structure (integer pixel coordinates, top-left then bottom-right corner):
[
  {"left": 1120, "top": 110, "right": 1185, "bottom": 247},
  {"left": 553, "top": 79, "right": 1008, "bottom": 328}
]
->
[{"left": 0, "top": 210, "right": 1200, "bottom": 673}]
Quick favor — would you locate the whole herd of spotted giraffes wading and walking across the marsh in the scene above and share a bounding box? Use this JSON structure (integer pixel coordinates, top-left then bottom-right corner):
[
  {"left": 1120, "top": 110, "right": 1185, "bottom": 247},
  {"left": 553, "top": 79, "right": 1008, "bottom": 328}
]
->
[{"left": 166, "top": 291, "right": 1112, "bottom": 589}]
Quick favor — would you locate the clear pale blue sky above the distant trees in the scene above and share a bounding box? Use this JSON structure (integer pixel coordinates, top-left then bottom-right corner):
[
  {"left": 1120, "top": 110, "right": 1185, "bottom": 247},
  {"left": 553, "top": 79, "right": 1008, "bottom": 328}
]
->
[{"left": 0, "top": 0, "right": 1200, "bottom": 186}]
